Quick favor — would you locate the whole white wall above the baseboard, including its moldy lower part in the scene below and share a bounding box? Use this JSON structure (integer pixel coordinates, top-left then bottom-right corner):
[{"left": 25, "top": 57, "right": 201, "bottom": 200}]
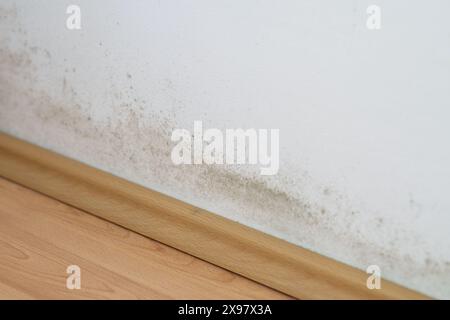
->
[{"left": 0, "top": 0, "right": 450, "bottom": 298}]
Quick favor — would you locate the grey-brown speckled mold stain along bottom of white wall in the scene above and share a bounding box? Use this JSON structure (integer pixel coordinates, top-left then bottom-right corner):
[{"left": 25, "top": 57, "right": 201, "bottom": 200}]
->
[{"left": 0, "top": 3, "right": 450, "bottom": 297}]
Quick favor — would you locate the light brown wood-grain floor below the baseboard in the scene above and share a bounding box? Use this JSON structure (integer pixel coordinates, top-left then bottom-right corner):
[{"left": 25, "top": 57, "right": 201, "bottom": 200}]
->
[{"left": 0, "top": 178, "right": 290, "bottom": 299}]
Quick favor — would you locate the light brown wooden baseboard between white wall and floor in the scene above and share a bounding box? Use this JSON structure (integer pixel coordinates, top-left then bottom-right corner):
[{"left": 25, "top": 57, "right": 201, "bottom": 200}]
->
[{"left": 0, "top": 132, "right": 427, "bottom": 299}]
